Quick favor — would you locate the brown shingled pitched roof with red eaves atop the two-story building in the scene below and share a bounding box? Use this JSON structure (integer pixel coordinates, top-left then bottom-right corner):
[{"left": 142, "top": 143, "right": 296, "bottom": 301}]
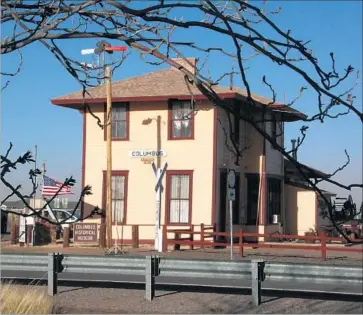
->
[{"left": 51, "top": 68, "right": 306, "bottom": 120}]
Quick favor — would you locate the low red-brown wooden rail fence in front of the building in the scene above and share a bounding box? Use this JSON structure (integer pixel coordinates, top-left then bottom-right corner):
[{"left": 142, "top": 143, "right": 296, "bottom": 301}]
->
[{"left": 7, "top": 224, "right": 363, "bottom": 261}]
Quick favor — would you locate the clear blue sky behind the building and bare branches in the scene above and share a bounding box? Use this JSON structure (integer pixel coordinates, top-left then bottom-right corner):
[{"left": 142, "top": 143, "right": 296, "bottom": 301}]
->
[{"left": 0, "top": 1, "right": 362, "bottom": 207}]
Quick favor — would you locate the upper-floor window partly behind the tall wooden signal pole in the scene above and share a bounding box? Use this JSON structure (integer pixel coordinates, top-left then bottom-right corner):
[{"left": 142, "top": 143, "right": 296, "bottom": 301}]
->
[{"left": 105, "top": 103, "right": 129, "bottom": 140}]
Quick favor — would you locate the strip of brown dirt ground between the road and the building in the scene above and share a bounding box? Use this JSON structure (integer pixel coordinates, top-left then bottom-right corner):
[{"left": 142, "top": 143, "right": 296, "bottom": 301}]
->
[{"left": 1, "top": 244, "right": 363, "bottom": 265}]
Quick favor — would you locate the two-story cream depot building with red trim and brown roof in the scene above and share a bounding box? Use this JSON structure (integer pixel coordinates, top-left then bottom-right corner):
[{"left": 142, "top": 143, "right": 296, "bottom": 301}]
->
[{"left": 52, "top": 59, "right": 336, "bottom": 243}]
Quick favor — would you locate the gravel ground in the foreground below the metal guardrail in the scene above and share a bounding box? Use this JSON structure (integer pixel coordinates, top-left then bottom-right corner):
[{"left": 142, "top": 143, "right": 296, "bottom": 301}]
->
[{"left": 12, "top": 286, "right": 363, "bottom": 314}]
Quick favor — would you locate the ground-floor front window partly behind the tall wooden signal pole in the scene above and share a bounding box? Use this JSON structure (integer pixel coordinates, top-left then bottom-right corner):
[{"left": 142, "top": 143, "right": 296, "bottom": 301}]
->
[{"left": 103, "top": 171, "right": 128, "bottom": 224}]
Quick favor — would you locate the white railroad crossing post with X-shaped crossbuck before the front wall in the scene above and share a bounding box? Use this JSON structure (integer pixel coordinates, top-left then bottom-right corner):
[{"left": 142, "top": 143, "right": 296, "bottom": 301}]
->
[{"left": 151, "top": 162, "right": 168, "bottom": 252}]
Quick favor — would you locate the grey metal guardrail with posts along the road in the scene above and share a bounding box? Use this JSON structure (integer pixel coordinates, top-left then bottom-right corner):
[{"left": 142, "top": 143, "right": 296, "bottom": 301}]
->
[{"left": 1, "top": 253, "right": 363, "bottom": 306}]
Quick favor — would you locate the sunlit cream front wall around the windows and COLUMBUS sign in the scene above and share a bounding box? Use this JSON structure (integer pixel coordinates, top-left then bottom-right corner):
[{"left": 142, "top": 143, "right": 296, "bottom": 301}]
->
[{"left": 85, "top": 102, "right": 214, "bottom": 239}]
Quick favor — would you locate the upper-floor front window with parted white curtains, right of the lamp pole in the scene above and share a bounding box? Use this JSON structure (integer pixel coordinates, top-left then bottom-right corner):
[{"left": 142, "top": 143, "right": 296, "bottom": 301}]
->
[{"left": 169, "top": 101, "right": 194, "bottom": 140}]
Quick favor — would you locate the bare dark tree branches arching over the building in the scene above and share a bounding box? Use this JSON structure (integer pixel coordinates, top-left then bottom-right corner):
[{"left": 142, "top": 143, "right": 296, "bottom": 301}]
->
[{"left": 1, "top": 0, "right": 363, "bottom": 240}]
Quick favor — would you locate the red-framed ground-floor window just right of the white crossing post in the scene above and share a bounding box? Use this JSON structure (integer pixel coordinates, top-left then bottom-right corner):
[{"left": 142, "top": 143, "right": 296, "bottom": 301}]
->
[{"left": 166, "top": 171, "right": 193, "bottom": 224}]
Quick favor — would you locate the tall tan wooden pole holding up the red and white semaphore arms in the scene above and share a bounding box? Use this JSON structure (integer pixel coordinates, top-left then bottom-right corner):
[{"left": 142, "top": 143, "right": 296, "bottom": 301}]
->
[{"left": 106, "top": 67, "right": 112, "bottom": 248}]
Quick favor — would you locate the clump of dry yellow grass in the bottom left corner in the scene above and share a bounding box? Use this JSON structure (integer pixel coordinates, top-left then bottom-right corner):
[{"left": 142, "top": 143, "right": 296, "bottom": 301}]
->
[{"left": 0, "top": 283, "right": 53, "bottom": 314}]
